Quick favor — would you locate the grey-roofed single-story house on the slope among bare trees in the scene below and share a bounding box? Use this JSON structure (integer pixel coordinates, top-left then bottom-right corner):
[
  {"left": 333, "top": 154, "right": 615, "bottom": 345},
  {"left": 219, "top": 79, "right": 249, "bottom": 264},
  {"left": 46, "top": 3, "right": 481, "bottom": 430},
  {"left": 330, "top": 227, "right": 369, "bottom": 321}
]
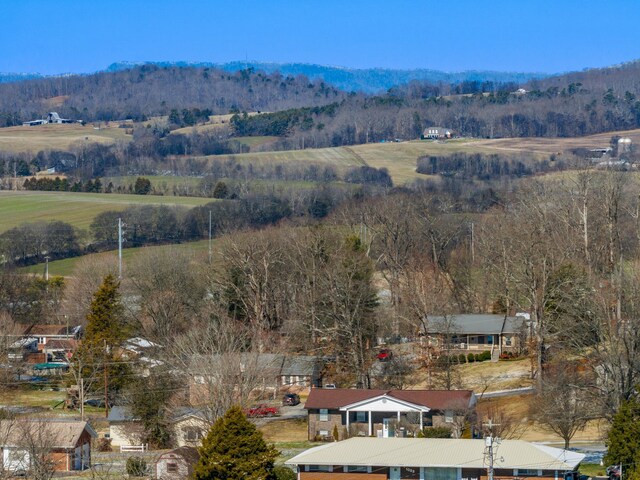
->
[{"left": 421, "top": 313, "right": 531, "bottom": 354}]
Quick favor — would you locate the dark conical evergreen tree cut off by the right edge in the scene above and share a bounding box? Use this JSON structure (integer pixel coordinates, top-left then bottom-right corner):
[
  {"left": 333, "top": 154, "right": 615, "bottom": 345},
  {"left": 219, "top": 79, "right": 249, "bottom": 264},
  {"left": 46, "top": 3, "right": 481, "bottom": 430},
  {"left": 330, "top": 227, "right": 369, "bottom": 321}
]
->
[{"left": 604, "top": 398, "right": 640, "bottom": 468}]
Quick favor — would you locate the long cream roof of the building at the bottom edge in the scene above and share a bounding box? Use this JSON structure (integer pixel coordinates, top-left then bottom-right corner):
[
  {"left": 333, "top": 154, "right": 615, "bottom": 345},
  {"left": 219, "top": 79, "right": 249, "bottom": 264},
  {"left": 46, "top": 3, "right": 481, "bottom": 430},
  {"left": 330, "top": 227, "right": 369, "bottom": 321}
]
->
[{"left": 286, "top": 437, "right": 584, "bottom": 471}]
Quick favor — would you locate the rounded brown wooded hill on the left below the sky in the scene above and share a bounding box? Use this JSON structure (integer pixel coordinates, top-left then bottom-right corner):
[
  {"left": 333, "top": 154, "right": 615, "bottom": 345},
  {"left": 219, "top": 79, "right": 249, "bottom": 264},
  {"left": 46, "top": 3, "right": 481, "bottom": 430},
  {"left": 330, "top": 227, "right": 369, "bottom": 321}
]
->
[{"left": 0, "top": 65, "right": 344, "bottom": 126}]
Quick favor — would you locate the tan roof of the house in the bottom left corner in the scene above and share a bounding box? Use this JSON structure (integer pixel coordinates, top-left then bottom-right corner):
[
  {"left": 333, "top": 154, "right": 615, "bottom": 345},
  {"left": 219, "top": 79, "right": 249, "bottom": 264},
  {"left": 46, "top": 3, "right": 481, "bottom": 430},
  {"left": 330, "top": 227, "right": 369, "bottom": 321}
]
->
[{"left": 0, "top": 419, "right": 98, "bottom": 448}]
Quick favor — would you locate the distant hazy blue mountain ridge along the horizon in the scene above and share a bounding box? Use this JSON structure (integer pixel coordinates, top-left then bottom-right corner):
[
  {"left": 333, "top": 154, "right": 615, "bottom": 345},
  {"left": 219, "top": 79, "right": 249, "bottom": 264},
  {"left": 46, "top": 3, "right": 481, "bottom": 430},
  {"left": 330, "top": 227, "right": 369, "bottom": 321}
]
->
[{"left": 106, "top": 61, "right": 550, "bottom": 93}]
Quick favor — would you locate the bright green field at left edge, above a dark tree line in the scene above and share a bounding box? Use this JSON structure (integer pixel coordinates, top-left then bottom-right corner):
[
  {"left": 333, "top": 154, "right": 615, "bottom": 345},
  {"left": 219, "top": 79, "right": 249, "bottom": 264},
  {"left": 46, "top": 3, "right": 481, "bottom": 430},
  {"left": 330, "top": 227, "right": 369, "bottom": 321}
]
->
[{"left": 0, "top": 191, "right": 214, "bottom": 232}]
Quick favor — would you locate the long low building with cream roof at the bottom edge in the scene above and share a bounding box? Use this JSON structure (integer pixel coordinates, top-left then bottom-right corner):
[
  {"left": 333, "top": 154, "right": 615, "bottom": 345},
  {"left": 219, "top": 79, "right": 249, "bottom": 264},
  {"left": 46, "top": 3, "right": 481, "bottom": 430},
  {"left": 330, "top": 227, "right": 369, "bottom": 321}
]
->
[{"left": 286, "top": 438, "right": 584, "bottom": 480}]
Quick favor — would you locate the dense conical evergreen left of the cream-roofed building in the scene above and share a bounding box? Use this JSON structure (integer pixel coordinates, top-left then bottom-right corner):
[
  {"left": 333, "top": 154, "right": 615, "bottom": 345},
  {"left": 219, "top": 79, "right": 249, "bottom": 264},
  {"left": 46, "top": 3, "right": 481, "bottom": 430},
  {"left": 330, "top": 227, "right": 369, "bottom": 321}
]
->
[{"left": 194, "top": 407, "right": 278, "bottom": 480}]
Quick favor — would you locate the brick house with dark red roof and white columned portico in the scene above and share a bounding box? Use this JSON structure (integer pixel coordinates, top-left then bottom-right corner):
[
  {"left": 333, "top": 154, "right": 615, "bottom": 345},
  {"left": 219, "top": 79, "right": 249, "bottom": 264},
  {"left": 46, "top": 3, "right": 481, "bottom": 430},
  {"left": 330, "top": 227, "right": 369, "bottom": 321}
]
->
[{"left": 304, "top": 388, "right": 477, "bottom": 440}]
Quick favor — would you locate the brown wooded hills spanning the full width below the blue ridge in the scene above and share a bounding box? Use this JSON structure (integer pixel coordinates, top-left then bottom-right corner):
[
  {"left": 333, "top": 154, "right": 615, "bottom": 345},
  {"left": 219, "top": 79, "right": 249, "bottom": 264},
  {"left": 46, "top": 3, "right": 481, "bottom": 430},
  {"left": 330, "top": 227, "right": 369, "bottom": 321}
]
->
[{"left": 0, "top": 62, "right": 640, "bottom": 143}]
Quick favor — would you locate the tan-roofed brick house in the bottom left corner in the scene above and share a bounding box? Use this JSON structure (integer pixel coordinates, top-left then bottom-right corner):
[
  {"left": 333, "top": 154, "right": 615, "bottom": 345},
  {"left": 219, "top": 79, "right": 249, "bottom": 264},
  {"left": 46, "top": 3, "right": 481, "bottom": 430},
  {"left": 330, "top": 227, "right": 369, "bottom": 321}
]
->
[{"left": 0, "top": 419, "right": 97, "bottom": 472}]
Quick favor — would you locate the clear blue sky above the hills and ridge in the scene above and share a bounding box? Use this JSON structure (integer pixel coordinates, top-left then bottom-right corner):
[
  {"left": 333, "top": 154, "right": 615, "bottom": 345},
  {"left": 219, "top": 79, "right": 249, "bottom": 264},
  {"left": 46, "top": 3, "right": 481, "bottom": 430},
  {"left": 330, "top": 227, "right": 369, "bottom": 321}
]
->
[{"left": 0, "top": 0, "right": 640, "bottom": 74}]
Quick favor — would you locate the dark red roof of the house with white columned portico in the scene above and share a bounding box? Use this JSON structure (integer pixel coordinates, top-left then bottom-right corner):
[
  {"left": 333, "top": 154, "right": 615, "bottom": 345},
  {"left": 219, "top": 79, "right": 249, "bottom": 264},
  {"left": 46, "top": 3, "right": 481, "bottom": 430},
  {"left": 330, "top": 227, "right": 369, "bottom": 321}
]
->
[{"left": 304, "top": 388, "right": 474, "bottom": 410}]
